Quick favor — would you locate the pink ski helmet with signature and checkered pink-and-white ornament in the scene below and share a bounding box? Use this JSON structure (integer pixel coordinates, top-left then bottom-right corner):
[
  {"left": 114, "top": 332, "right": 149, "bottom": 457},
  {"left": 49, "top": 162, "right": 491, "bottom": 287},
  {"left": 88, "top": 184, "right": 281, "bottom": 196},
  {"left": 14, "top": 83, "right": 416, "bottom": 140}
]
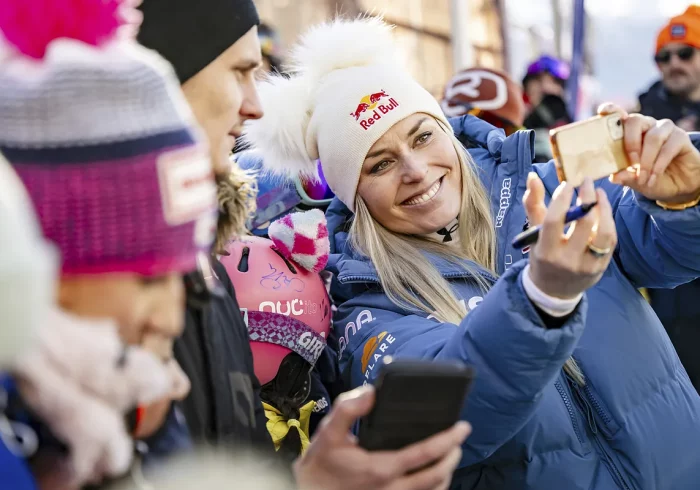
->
[{"left": 221, "top": 209, "right": 332, "bottom": 385}]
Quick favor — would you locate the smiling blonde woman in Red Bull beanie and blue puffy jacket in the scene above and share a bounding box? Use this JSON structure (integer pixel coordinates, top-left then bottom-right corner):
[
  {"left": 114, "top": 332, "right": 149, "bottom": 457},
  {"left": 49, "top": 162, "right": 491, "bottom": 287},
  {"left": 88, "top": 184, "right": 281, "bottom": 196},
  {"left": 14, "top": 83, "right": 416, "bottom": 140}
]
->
[{"left": 247, "top": 19, "right": 700, "bottom": 490}]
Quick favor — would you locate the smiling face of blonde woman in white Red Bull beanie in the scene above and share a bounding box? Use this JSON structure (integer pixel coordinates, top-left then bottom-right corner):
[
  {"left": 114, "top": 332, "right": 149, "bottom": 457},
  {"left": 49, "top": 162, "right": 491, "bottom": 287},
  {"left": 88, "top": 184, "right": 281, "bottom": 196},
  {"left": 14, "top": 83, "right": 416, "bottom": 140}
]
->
[{"left": 357, "top": 113, "right": 462, "bottom": 235}]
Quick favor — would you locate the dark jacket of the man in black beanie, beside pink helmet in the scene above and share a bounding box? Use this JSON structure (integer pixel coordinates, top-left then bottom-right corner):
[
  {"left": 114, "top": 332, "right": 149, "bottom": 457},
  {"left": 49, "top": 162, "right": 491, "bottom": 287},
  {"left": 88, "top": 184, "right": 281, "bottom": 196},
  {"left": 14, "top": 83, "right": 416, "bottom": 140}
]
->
[{"left": 175, "top": 260, "right": 272, "bottom": 451}]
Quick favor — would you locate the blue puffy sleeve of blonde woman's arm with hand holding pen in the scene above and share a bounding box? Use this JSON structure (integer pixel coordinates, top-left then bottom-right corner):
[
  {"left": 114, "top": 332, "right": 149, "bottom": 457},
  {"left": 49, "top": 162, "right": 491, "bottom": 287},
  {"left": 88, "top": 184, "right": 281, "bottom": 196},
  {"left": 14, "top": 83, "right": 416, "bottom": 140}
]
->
[{"left": 338, "top": 262, "right": 586, "bottom": 464}]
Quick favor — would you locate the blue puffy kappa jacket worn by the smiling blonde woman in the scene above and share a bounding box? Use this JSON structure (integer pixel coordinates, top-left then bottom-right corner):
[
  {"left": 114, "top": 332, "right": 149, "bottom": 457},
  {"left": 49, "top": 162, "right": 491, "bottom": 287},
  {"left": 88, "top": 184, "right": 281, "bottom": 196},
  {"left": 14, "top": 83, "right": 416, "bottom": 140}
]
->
[{"left": 328, "top": 116, "right": 700, "bottom": 490}]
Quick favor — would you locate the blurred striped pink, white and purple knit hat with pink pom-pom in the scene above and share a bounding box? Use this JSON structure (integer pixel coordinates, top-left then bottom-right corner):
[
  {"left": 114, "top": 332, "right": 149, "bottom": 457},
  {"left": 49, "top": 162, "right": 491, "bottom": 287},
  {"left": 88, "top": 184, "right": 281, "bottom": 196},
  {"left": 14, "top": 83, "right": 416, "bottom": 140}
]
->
[{"left": 0, "top": 0, "right": 216, "bottom": 276}]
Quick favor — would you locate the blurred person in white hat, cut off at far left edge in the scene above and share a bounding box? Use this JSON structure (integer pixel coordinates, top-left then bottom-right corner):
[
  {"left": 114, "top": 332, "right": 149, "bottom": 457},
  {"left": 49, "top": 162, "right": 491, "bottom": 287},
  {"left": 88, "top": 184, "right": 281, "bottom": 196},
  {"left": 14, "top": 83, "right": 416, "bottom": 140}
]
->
[{"left": 0, "top": 155, "right": 185, "bottom": 490}]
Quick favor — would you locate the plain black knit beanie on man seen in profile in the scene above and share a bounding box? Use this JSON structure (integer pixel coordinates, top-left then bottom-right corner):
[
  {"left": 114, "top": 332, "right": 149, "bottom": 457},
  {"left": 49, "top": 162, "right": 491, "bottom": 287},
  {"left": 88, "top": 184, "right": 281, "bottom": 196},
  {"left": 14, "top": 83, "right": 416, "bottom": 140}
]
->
[{"left": 138, "top": 0, "right": 260, "bottom": 83}]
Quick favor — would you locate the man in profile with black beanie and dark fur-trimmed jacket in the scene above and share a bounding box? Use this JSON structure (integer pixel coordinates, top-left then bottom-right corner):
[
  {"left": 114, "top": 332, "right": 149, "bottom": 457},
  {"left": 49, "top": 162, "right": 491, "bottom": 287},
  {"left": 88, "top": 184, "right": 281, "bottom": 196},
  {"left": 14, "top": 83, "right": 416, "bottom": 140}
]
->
[{"left": 138, "top": 0, "right": 272, "bottom": 448}]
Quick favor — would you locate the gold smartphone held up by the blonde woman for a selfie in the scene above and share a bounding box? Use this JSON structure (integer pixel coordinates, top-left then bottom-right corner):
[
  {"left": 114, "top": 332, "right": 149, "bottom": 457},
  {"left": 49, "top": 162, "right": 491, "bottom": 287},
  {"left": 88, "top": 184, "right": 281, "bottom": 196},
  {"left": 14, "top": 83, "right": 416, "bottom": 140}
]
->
[{"left": 549, "top": 114, "right": 631, "bottom": 187}]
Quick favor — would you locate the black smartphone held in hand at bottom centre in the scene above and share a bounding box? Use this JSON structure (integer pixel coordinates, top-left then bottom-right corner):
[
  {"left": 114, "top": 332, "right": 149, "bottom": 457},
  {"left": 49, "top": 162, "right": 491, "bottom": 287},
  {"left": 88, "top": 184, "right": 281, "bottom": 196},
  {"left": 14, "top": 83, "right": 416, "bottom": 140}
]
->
[{"left": 359, "top": 357, "right": 474, "bottom": 451}]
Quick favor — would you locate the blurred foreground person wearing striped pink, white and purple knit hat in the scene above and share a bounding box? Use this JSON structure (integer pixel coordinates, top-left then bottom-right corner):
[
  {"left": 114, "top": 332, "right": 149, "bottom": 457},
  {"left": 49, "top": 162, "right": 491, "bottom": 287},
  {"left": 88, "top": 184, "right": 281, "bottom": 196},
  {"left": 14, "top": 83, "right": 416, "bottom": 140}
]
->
[{"left": 0, "top": 0, "right": 216, "bottom": 488}]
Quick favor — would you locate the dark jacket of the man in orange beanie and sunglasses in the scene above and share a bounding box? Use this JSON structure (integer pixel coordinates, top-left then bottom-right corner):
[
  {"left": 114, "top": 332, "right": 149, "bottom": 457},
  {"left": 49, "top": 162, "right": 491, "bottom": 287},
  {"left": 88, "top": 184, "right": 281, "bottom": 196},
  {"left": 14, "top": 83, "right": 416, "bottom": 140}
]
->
[{"left": 639, "top": 81, "right": 700, "bottom": 392}]
